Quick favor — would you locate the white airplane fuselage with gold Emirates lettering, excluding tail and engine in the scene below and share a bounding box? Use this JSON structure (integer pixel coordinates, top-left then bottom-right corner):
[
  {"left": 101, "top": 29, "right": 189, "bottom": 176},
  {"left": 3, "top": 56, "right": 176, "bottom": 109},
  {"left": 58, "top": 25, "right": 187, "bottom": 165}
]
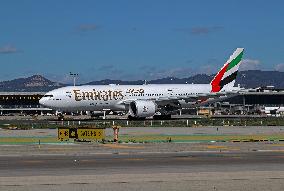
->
[{"left": 40, "top": 84, "right": 211, "bottom": 111}]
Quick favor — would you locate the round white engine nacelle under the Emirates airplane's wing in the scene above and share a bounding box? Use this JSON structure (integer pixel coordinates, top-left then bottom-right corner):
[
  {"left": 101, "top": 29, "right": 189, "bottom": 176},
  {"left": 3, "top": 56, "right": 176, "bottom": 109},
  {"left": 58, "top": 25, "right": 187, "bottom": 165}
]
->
[{"left": 129, "top": 100, "right": 157, "bottom": 118}]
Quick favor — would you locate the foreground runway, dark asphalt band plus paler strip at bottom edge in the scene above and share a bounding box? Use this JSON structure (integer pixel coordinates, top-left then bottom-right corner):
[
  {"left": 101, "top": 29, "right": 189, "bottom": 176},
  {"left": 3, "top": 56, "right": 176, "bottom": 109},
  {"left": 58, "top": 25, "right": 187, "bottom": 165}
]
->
[{"left": 0, "top": 151, "right": 284, "bottom": 190}]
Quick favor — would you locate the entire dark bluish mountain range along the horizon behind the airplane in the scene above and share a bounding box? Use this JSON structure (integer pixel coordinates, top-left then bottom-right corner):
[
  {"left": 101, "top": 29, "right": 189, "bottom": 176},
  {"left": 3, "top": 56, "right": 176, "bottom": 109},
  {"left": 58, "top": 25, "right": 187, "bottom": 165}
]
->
[{"left": 0, "top": 70, "right": 284, "bottom": 92}]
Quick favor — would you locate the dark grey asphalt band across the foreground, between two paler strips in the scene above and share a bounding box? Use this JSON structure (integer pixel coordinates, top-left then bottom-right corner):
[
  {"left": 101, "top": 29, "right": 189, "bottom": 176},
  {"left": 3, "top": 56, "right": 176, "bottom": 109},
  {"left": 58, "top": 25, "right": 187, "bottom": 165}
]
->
[{"left": 0, "top": 151, "right": 284, "bottom": 177}]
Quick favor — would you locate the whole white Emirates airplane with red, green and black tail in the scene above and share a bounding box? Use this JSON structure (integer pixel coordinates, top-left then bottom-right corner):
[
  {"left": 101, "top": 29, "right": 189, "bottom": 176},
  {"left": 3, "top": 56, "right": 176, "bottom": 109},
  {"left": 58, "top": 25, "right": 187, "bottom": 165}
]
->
[{"left": 39, "top": 48, "right": 244, "bottom": 120}]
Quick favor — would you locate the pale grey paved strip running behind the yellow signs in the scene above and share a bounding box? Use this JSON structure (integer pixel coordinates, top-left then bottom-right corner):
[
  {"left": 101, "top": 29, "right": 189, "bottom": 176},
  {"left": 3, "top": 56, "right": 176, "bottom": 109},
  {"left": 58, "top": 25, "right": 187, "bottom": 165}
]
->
[{"left": 0, "top": 126, "right": 284, "bottom": 138}]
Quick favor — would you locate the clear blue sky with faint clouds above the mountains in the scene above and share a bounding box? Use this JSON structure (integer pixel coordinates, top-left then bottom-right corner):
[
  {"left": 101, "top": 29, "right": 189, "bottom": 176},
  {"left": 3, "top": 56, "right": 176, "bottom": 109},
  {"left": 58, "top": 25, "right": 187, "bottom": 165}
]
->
[{"left": 0, "top": 0, "right": 284, "bottom": 83}]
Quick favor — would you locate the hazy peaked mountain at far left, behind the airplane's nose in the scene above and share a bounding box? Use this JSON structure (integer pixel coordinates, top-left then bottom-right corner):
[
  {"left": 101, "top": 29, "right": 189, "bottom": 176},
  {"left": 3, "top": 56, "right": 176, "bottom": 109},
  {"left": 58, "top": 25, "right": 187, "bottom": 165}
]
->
[{"left": 0, "top": 75, "right": 65, "bottom": 92}]
